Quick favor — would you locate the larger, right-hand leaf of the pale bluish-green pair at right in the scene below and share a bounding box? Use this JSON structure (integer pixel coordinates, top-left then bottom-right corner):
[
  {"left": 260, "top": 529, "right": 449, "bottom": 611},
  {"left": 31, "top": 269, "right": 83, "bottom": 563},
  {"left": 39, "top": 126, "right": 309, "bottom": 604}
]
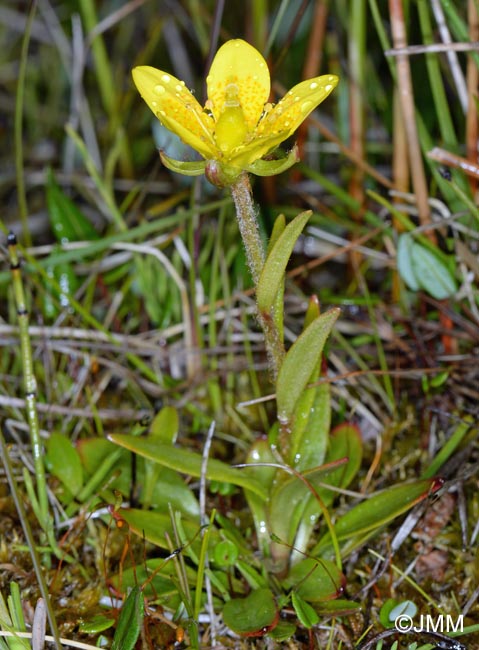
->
[{"left": 411, "top": 242, "right": 457, "bottom": 300}]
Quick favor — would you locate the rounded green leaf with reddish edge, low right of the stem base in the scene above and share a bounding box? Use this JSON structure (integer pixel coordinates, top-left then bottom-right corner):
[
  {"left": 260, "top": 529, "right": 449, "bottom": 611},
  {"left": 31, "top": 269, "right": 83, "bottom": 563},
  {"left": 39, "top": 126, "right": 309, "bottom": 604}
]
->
[{"left": 285, "top": 557, "right": 346, "bottom": 603}]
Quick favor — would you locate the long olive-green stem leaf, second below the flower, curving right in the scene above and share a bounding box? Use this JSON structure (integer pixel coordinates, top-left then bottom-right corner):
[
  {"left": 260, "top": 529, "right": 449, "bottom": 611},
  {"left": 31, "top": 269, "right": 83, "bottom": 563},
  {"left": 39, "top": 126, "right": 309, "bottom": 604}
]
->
[{"left": 276, "top": 308, "right": 340, "bottom": 424}]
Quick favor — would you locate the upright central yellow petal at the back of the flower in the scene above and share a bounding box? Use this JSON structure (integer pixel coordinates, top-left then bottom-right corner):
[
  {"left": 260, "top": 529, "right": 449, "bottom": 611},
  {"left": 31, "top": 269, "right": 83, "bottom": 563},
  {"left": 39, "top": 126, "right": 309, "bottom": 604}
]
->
[{"left": 206, "top": 38, "right": 271, "bottom": 131}]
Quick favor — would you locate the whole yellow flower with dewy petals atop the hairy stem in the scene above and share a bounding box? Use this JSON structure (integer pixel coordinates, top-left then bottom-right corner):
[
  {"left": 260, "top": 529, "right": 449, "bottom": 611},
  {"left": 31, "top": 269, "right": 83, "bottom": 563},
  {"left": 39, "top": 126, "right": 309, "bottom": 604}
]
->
[{"left": 132, "top": 39, "right": 338, "bottom": 185}]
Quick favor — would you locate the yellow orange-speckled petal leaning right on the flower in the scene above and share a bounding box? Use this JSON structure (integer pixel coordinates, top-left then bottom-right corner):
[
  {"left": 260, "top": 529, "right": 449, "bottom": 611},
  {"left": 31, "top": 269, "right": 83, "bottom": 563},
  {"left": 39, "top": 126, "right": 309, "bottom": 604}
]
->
[{"left": 258, "top": 74, "right": 339, "bottom": 144}]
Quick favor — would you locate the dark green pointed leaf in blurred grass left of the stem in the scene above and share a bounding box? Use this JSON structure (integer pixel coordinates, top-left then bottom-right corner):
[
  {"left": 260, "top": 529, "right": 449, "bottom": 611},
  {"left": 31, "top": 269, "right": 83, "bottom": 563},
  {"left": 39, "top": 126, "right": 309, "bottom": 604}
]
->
[{"left": 46, "top": 170, "right": 99, "bottom": 244}]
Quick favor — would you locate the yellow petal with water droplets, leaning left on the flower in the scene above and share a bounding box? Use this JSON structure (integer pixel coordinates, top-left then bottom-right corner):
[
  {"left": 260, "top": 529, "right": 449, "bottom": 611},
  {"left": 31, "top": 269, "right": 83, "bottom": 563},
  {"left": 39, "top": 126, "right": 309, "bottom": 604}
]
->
[{"left": 132, "top": 65, "right": 218, "bottom": 158}]
